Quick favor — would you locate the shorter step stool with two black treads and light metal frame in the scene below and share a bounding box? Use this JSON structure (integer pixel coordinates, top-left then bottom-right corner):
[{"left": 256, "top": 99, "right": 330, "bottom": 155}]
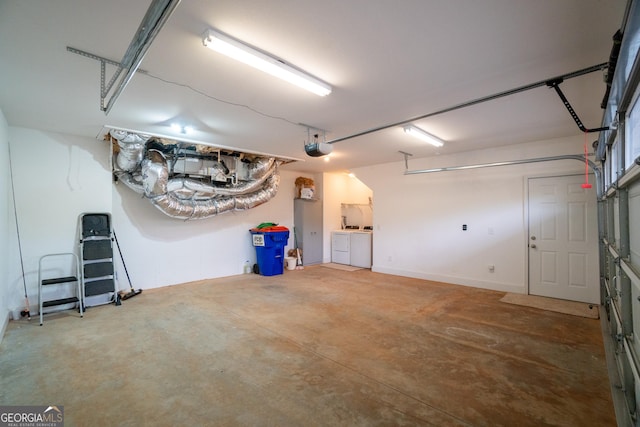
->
[{"left": 38, "top": 252, "right": 84, "bottom": 326}]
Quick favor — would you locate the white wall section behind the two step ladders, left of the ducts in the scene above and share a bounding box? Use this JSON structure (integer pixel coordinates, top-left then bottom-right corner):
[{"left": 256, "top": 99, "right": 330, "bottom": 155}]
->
[{"left": 8, "top": 127, "right": 111, "bottom": 314}]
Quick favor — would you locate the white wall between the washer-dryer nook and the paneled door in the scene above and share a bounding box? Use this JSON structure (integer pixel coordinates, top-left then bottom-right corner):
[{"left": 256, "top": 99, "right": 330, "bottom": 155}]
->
[{"left": 354, "top": 137, "right": 595, "bottom": 293}]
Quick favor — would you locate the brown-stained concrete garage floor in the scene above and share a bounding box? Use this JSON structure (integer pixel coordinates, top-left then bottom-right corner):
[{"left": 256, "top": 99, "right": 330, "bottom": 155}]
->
[{"left": 0, "top": 266, "right": 615, "bottom": 426}]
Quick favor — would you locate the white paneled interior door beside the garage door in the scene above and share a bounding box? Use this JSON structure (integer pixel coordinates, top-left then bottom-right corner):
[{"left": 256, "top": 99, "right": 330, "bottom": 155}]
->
[{"left": 528, "top": 175, "right": 600, "bottom": 304}]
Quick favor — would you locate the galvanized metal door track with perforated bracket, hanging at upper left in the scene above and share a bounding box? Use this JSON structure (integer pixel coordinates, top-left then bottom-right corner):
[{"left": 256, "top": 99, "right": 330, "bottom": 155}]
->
[{"left": 67, "top": 0, "right": 181, "bottom": 115}]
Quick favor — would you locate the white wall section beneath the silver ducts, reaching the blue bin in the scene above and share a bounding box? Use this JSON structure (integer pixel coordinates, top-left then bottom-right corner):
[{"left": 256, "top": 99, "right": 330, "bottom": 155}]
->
[{"left": 113, "top": 171, "right": 298, "bottom": 289}]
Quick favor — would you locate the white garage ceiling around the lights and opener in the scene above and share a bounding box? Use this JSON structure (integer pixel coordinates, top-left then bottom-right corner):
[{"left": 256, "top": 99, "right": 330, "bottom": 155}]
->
[{"left": 0, "top": 0, "right": 626, "bottom": 172}]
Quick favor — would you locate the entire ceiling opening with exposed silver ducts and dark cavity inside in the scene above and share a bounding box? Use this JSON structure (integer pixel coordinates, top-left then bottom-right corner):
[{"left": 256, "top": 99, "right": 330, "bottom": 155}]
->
[{"left": 111, "top": 131, "right": 282, "bottom": 219}]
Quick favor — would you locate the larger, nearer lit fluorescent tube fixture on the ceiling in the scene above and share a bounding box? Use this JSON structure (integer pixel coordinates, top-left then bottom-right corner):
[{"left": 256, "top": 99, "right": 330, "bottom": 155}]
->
[{"left": 202, "top": 30, "right": 331, "bottom": 96}]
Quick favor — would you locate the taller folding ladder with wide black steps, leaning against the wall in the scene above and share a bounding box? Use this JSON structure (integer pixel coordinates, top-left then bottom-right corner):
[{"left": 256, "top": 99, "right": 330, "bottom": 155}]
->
[{"left": 79, "top": 213, "right": 119, "bottom": 307}]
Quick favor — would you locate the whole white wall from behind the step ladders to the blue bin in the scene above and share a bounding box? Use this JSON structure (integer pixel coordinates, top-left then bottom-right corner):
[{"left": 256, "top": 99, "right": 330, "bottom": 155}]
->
[{"left": 0, "top": 126, "right": 299, "bottom": 313}]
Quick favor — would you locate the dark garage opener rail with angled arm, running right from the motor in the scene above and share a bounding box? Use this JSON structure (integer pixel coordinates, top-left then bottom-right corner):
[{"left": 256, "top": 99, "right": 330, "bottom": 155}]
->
[{"left": 327, "top": 62, "right": 609, "bottom": 144}]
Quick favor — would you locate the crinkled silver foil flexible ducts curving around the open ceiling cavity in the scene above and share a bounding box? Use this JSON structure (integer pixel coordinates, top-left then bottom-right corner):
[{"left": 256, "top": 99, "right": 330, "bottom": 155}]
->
[{"left": 112, "top": 131, "right": 281, "bottom": 220}]
